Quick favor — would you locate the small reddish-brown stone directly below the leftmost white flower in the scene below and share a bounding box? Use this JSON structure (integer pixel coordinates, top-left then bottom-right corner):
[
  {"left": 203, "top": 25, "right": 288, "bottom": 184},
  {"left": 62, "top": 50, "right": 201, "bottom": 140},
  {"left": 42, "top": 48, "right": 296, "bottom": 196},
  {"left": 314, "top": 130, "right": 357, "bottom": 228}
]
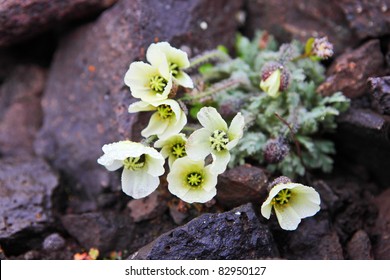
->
[{"left": 127, "top": 191, "right": 168, "bottom": 223}]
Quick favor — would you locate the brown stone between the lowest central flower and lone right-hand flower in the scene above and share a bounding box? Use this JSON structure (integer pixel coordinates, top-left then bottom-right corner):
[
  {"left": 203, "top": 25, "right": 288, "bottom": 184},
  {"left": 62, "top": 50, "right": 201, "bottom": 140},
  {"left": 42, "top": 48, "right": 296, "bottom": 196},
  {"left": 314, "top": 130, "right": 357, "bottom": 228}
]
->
[{"left": 216, "top": 164, "right": 268, "bottom": 208}]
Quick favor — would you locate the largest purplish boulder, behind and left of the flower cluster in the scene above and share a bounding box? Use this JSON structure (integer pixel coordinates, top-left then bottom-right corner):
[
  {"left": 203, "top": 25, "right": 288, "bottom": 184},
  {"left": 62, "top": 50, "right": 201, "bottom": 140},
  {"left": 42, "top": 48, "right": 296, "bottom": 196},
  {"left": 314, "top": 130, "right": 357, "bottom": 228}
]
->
[{"left": 35, "top": 0, "right": 242, "bottom": 201}]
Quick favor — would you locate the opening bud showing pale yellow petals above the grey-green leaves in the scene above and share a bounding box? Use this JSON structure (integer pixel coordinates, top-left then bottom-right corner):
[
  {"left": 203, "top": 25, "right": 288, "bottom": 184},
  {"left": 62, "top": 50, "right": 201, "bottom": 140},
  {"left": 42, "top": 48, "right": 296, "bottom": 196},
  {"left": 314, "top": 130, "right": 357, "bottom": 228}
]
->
[{"left": 260, "top": 62, "right": 290, "bottom": 97}]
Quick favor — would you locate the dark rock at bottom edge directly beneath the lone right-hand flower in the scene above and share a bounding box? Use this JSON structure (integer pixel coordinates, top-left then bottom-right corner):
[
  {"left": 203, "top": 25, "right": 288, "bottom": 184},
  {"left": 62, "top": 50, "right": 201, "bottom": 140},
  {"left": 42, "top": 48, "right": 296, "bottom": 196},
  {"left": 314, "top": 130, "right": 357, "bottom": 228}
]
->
[{"left": 273, "top": 212, "right": 344, "bottom": 260}]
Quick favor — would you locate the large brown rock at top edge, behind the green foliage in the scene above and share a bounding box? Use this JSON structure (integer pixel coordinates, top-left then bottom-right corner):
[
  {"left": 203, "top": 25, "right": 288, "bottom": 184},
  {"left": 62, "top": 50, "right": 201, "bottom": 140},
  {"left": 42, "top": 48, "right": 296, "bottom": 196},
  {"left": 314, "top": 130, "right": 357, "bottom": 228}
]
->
[{"left": 246, "top": 0, "right": 353, "bottom": 52}]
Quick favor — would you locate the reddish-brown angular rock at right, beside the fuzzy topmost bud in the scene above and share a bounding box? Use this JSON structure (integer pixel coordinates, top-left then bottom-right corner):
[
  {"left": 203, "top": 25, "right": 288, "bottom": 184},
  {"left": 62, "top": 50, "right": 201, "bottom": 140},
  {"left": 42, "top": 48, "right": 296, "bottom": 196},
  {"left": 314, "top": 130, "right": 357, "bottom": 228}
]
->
[{"left": 318, "top": 40, "right": 385, "bottom": 98}]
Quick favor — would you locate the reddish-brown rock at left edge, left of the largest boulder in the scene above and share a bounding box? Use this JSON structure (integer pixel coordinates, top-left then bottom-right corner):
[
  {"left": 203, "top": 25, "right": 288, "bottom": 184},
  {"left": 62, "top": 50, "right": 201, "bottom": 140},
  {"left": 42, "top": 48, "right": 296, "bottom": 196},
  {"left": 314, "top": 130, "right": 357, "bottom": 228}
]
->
[{"left": 0, "top": 65, "right": 46, "bottom": 156}]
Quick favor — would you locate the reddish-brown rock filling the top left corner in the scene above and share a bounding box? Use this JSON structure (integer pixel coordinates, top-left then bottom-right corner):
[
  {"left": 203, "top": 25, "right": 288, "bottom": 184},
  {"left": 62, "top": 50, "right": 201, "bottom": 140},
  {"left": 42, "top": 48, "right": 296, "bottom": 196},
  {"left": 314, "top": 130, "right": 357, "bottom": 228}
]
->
[{"left": 0, "top": 0, "right": 116, "bottom": 47}]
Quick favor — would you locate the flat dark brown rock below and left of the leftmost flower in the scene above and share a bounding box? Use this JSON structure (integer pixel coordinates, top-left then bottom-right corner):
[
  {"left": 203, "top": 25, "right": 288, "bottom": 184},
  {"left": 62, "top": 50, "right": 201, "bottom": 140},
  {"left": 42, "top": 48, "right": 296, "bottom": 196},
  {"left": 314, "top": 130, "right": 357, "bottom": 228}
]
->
[{"left": 61, "top": 211, "right": 134, "bottom": 254}]
